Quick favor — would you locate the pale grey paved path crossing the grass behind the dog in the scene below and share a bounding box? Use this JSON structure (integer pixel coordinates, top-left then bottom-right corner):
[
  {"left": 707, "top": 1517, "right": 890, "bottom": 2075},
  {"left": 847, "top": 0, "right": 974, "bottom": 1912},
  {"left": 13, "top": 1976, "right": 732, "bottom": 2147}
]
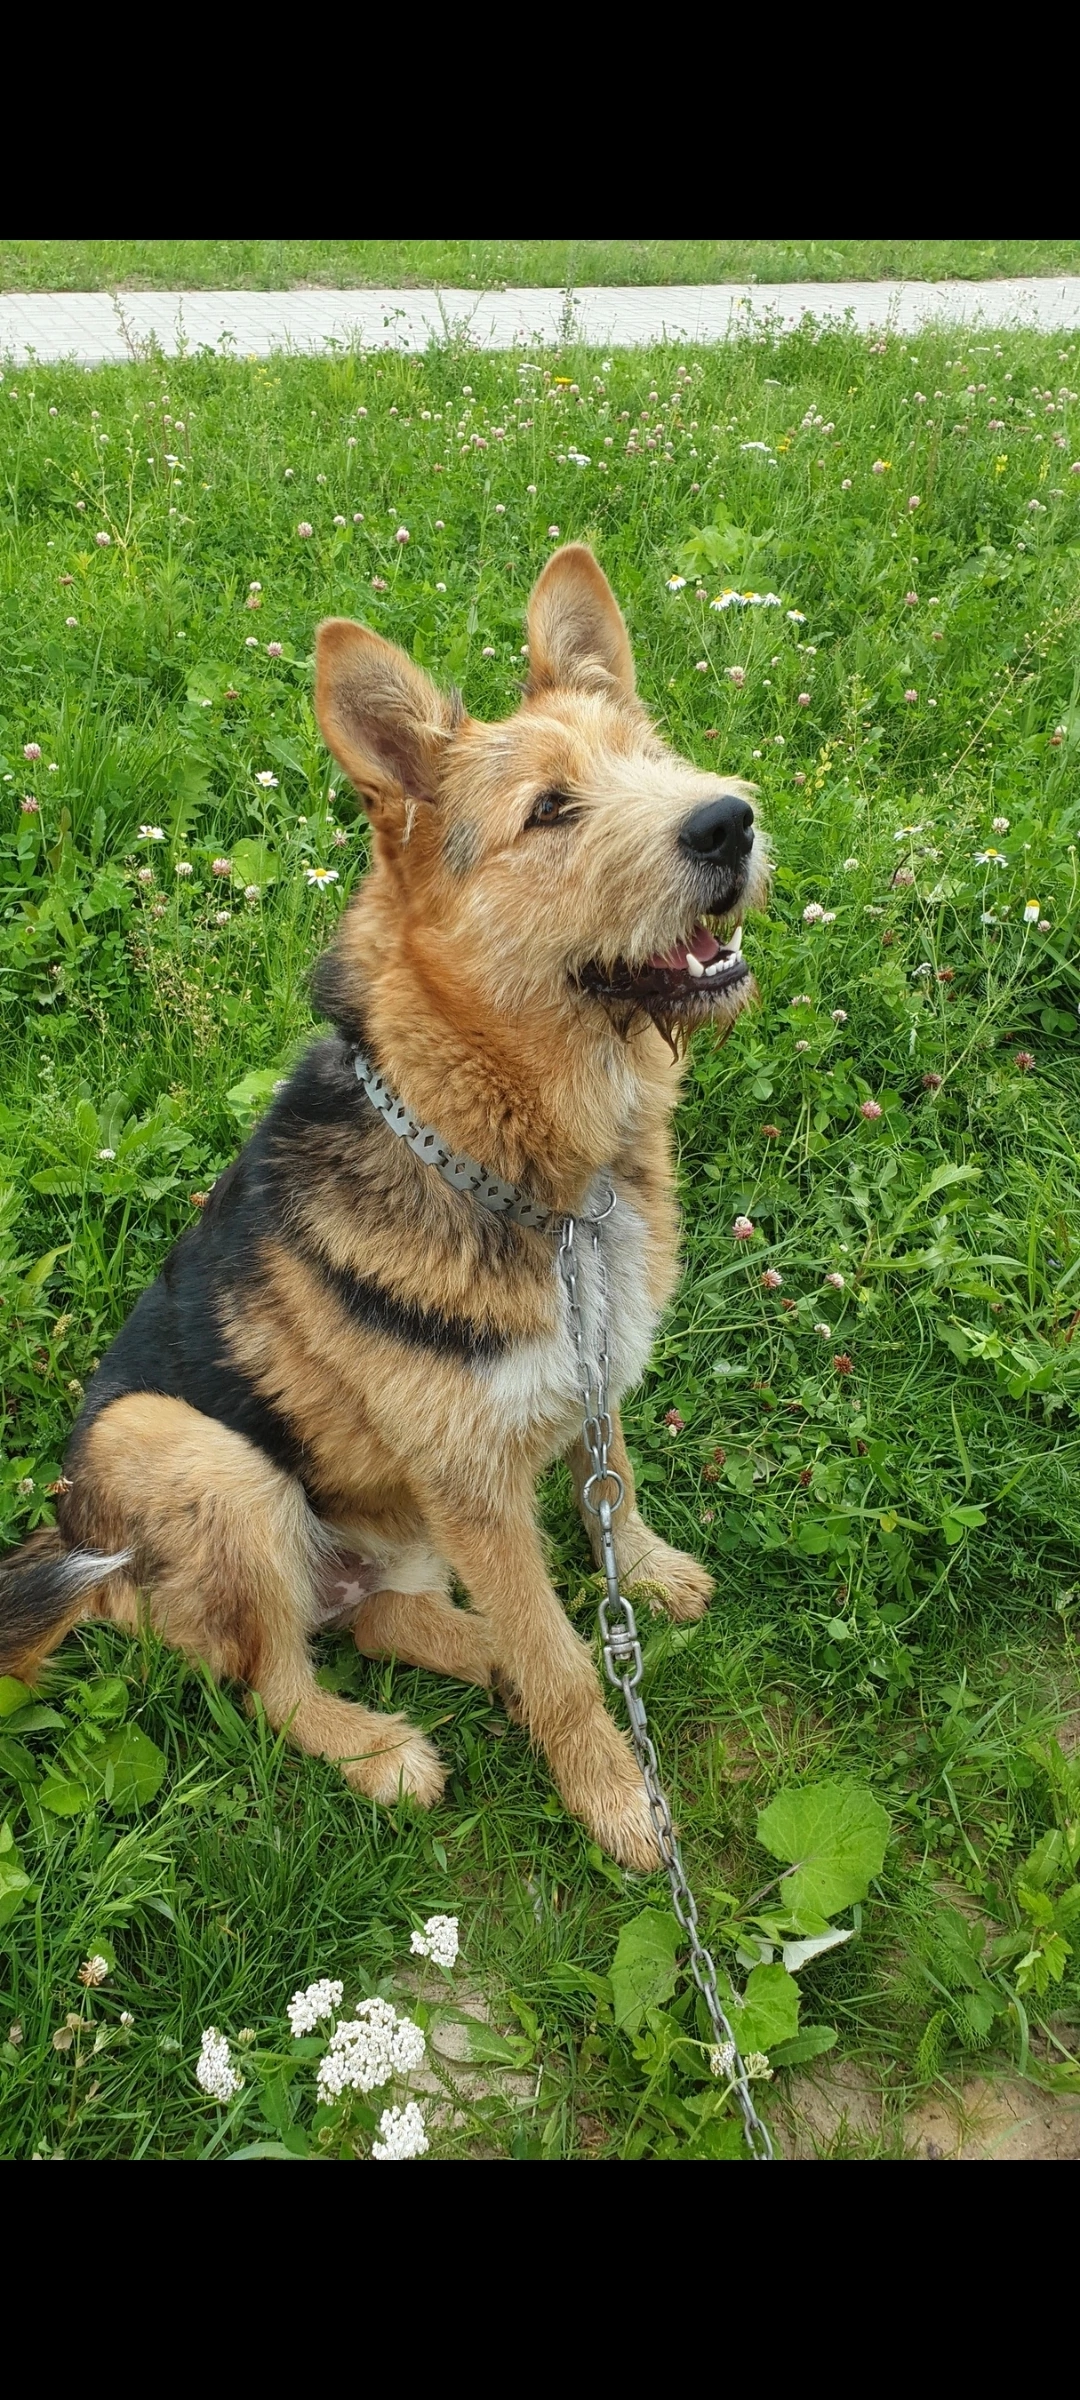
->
[{"left": 0, "top": 276, "right": 1080, "bottom": 367}]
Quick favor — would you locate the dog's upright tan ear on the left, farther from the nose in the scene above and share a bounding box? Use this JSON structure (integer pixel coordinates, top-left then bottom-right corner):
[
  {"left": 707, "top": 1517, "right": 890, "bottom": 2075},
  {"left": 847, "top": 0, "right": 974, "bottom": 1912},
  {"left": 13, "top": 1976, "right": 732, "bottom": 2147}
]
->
[{"left": 314, "top": 617, "right": 461, "bottom": 816}]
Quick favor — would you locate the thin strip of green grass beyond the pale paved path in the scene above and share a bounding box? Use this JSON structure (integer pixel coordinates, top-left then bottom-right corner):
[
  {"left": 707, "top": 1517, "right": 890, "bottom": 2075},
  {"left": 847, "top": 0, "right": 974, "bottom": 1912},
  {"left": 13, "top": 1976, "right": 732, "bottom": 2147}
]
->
[{"left": 0, "top": 242, "right": 1080, "bottom": 293}]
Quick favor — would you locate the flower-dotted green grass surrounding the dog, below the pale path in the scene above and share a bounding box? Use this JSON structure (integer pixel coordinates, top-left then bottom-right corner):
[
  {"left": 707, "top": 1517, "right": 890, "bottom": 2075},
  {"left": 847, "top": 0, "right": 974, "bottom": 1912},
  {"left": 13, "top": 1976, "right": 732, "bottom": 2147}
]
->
[{"left": 0, "top": 326, "right": 1080, "bottom": 2158}]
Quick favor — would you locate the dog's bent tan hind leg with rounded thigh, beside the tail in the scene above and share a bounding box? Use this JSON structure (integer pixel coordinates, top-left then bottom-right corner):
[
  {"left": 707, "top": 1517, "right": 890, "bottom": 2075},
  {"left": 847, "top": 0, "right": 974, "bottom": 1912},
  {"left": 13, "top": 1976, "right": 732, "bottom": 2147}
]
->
[{"left": 65, "top": 1392, "right": 444, "bottom": 1805}]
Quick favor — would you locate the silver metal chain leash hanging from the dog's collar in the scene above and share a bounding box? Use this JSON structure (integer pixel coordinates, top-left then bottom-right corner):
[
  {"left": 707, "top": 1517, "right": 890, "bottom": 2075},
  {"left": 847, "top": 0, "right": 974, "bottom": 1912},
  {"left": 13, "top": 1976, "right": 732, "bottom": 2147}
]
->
[{"left": 559, "top": 1190, "right": 773, "bottom": 2158}]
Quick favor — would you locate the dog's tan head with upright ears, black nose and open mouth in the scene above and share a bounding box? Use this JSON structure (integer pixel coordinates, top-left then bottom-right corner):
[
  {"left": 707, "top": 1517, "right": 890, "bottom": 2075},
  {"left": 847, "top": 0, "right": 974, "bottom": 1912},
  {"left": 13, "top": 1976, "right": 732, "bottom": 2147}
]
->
[{"left": 317, "top": 545, "right": 768, "bottom": 1060}]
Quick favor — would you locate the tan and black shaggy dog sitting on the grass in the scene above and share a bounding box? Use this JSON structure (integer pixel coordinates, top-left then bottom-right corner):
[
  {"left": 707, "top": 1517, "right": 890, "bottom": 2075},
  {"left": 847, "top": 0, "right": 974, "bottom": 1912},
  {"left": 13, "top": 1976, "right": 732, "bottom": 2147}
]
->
[{"left": 0, "top": 545, "right": 768, "bottom": 1867}]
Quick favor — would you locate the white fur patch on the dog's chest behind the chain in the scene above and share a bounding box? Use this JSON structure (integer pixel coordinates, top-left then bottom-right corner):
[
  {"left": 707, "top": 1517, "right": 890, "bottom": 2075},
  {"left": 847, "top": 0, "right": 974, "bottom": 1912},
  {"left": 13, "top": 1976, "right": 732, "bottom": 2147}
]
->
[{"left": 482, "top": 1178, "right": 658, "bottom": 1457}]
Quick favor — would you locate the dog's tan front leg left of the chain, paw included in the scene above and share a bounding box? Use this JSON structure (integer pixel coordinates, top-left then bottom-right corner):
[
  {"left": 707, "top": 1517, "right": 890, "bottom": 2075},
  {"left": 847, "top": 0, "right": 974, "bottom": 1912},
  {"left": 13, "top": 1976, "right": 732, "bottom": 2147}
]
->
[{"left": 425, "top": 1483, "right": 660, "bottom": 1870}]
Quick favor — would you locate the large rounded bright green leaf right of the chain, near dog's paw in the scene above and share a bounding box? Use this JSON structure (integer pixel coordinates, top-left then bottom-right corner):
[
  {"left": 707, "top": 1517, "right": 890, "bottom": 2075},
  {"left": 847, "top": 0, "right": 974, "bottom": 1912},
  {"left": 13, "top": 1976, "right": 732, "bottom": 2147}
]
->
[{"left": 758, "top": 1776, "right": 888, "bottom": 1918}]
